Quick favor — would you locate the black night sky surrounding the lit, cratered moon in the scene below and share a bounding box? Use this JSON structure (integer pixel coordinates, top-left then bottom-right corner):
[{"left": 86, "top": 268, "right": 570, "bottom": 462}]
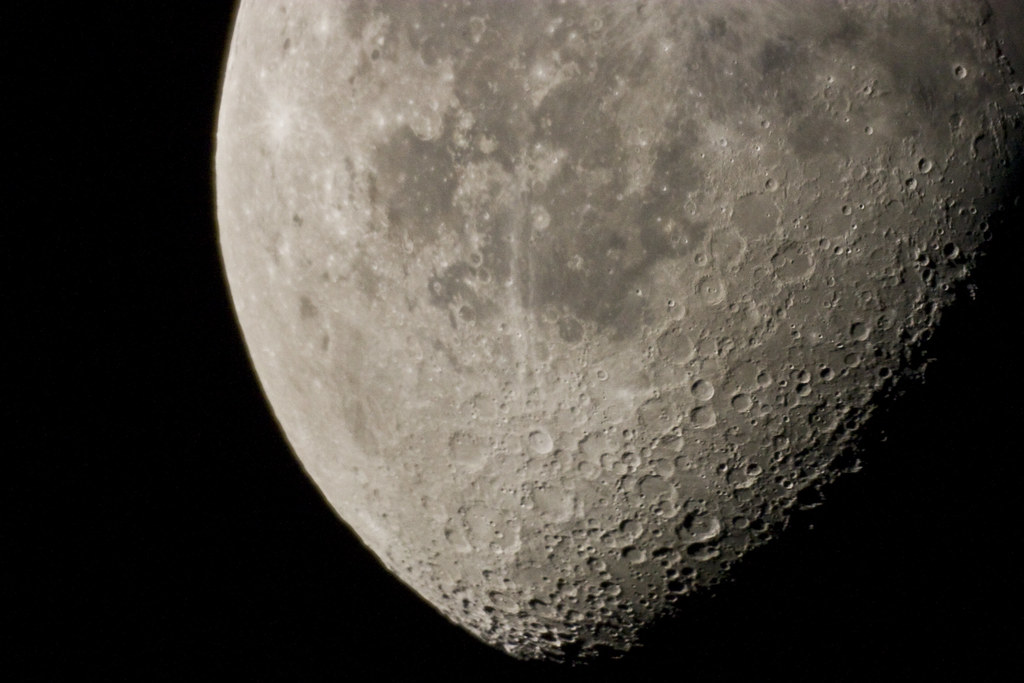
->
[{"left": 12, "top": 0, "right": 1024, "bottom": 681}]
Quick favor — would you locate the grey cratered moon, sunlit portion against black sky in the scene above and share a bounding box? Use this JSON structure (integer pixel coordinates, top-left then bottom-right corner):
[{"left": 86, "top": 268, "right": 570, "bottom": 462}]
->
[{"left": 216, "top": 0, "right": 1024, "bottom": 658}]
